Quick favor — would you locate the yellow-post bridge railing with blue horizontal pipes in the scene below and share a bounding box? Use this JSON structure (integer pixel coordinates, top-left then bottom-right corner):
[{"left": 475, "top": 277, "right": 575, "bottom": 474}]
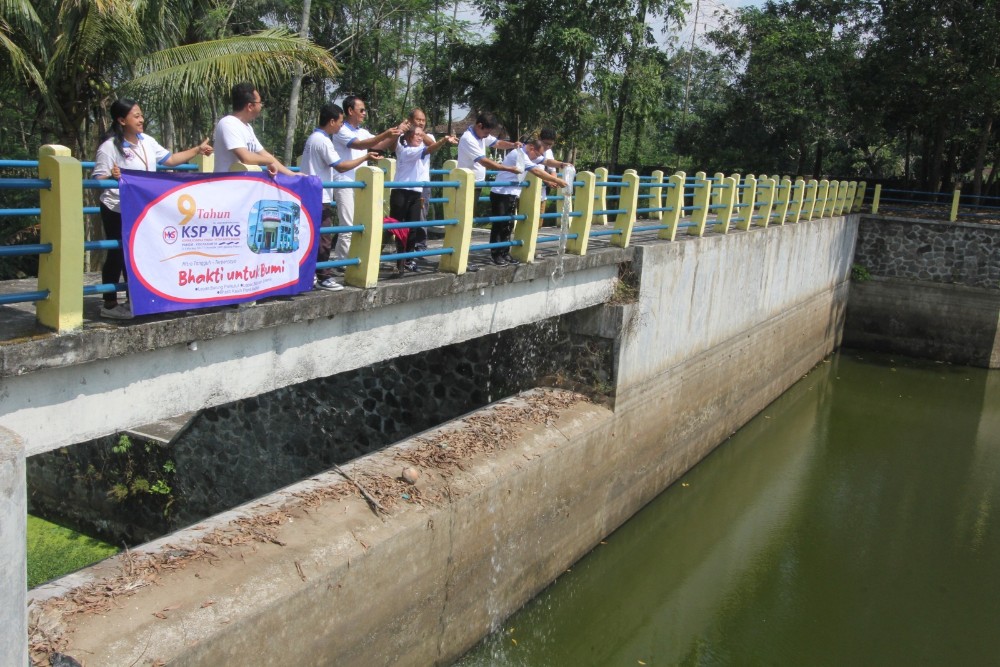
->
[{"left": 0, "top": 146, "right": 860, "bottom": 331}]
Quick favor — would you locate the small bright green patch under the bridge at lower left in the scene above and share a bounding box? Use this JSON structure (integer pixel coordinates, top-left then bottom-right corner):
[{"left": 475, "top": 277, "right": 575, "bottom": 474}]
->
[{"left": 28, "top": 515, "right": 118, "bottom": 588}]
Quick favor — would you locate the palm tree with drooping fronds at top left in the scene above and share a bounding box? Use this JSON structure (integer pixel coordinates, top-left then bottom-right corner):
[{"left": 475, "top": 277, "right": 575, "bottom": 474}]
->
[{"left": 0, "top": 0, "right": 338, "bottom": 154}]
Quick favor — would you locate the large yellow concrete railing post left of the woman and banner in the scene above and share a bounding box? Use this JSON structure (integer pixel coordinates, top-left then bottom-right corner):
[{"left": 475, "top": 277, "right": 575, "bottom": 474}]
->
[{"left": 35, "top": 144, "right": 84, "bottom": 332}]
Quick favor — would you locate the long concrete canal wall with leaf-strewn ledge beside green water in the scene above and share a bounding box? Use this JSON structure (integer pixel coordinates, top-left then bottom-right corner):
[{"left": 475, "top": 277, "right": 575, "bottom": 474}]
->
[{"left": 31, "top": 216, "right": 857, "bottom": 666}]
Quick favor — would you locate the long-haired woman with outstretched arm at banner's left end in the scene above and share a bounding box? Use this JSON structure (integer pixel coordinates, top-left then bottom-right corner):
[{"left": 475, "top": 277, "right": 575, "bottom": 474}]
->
[{"left": 93, "top": 98, "right": 212, "bottom": 320}]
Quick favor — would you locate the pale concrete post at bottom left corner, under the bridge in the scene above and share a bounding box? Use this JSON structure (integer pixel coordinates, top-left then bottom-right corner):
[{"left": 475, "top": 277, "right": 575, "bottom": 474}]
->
[{"left": 0, "top": 426, "right": 28, "bottom": 666}]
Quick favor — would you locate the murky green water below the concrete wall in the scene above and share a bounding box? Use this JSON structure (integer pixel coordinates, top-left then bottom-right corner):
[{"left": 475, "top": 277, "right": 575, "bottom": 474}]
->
[{"left": 458, "top": 351, "right": 1000, "bottom": 667}]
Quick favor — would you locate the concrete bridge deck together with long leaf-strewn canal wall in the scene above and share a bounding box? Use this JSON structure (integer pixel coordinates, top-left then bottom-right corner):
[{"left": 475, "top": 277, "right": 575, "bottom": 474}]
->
[{"left": 11, "top": 214, "right": 858, "bottom": 665}]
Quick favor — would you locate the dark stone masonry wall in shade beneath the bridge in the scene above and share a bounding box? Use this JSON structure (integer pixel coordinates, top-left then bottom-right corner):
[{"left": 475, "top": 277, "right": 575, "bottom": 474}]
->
[{"left": 28, "top": 314, "right": 613, "bottom": 544}]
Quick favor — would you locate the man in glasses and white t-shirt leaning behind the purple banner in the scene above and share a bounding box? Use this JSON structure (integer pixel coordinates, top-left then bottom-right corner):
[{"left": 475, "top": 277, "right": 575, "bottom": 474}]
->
[{"left": 214, "top": 83, "right": 295, "bottom": 176}]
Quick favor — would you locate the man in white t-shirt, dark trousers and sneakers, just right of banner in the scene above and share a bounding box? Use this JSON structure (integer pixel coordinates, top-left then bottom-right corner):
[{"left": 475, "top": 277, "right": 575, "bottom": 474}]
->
[{"left": 299, "top": 104, "right": 378, "bottom": 291}]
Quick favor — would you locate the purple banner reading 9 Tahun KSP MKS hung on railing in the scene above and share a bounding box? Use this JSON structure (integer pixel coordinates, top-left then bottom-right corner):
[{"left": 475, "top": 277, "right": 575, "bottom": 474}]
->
[{"left": 119, "top": 171, "right": 322, "bottom": 315}]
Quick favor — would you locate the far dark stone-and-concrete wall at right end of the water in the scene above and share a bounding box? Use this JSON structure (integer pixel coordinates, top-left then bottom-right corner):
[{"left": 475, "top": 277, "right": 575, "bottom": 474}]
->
[{"left": 844, "top": 216, "right": 1000, "bottom": 368}]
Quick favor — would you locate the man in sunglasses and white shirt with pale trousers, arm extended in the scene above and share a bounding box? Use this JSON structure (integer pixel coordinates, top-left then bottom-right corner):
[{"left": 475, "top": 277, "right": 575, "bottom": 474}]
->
[{"left": 331, "top": 95, "right": 410, "bottom": 259}]
